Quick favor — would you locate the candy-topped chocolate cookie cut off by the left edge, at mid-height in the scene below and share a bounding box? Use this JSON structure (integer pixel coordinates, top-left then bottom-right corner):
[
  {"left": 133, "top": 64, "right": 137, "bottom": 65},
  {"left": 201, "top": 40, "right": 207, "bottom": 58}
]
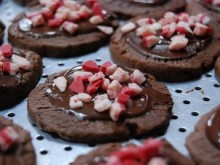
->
[{"left": 0, "top": 45, "right": 42, "bottom": 109}]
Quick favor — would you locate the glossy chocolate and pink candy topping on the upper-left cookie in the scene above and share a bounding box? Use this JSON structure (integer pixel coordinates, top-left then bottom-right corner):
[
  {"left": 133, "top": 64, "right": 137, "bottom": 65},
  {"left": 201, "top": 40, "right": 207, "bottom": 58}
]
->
[{"left": 18, "top": 2, "right": 116, "bottom": 38}]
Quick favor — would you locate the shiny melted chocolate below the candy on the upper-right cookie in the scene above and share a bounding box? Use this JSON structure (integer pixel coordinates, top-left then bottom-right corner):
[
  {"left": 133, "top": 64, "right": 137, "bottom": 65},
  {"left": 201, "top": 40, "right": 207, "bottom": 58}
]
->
[{"left": 126, "top": 31, "right": 211, "bottom": 61}]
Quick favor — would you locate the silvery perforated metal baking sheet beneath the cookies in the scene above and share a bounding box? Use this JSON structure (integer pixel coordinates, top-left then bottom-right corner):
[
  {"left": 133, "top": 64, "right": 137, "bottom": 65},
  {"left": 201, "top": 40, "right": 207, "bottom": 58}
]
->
[{"left": 0, "top": 0, "right": 220, "bottom": 165}]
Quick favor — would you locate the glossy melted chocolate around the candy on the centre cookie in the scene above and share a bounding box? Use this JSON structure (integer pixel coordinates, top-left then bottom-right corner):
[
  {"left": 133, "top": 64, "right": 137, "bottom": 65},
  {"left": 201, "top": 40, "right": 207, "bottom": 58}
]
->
[{"left": 45, "top": 67, "right": 169, "bottom": 120}]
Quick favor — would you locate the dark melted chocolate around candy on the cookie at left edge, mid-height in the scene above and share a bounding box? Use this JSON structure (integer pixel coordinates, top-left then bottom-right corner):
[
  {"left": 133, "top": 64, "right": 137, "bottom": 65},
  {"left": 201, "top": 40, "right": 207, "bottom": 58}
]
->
[{"left": 0, "top": 51, "right": 25, "bottom": 87}]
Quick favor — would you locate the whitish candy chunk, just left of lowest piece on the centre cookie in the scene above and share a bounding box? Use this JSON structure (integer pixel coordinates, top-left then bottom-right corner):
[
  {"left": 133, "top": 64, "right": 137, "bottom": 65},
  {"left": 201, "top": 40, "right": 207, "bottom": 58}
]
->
[{"left": 94, "top": 99, "right": 112, "bottom": 112}]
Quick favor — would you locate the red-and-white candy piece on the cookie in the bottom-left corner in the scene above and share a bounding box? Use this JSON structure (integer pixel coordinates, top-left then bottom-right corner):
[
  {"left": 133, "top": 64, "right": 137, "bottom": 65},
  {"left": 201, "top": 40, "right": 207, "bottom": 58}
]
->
[{"left": 0, "top": 126, "right": 19, "bottom": 151}]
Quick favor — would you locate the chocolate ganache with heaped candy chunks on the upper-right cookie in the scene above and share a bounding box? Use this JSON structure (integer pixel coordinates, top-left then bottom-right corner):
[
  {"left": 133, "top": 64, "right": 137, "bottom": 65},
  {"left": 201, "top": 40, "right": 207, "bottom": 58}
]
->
[{"left": 124, "top": 12, "right": 212, "bottom": 61}]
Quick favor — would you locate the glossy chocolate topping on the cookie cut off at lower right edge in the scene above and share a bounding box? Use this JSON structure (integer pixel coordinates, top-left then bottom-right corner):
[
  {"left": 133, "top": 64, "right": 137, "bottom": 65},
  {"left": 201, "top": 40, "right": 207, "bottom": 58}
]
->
[{"left": 205, "top": 106, "right": 220, "bottom": 149}]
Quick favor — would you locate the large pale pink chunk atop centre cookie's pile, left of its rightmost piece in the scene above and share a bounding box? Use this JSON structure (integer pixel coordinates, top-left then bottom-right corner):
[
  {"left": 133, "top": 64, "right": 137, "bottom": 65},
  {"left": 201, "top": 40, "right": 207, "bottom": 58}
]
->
[{"left": 109, "top": 67, "right": 130, "bottom": 83}]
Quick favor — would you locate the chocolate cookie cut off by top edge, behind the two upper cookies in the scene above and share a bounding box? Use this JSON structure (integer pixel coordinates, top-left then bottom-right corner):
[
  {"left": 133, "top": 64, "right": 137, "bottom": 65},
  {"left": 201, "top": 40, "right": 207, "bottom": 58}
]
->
[{"left": 79, "top": 0, "right": 186, "bottom": 18}]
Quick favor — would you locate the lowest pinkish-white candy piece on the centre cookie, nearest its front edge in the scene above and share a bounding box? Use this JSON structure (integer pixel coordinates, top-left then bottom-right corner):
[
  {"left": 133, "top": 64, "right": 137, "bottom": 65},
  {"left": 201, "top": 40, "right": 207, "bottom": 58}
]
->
[{"left": 109, "top": 103, "right": 125, "bottom": 121}]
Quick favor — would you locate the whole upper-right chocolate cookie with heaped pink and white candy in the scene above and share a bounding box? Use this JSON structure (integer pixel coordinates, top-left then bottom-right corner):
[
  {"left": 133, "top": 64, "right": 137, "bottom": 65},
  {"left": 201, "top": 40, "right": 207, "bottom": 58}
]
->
[{"left": 110, "top": 2, "right": 219, "bottom": 82}]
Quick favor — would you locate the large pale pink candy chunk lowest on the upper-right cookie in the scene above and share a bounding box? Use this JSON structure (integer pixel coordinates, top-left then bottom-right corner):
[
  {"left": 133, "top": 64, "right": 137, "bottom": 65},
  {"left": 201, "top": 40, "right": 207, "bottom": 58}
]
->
[{"left": 169, "top": 35, "right": 188, "bottom": 50}]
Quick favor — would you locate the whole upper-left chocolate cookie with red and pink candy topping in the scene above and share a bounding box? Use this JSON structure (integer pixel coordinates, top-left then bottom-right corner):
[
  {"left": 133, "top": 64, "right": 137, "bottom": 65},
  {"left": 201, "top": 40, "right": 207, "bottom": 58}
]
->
[{"left": 9, "top": 0, "right": 118, "bottom": 57}]
